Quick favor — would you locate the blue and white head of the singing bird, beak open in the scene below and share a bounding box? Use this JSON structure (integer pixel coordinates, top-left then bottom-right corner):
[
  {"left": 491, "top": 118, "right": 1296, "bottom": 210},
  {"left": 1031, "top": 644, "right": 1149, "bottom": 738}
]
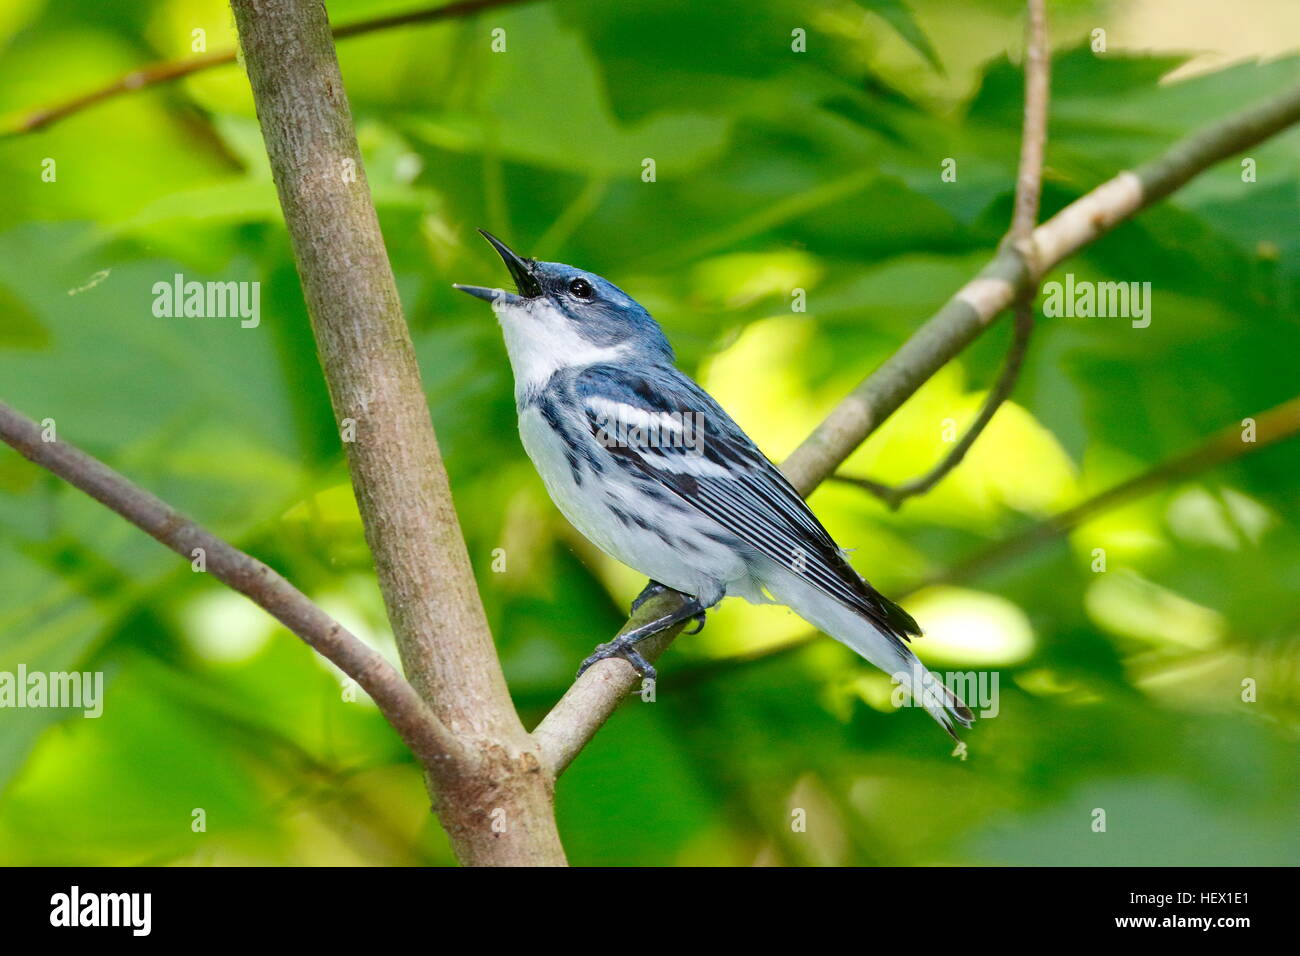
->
[{"left": 455, "top": 229, "right": 672, "bottom": 386}]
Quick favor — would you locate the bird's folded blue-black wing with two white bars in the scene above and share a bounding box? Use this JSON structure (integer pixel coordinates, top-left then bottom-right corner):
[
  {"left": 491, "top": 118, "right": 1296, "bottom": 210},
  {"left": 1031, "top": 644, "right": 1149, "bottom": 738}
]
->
[{"left": 575, "top": 364, "right": 920, "bottom": 640}]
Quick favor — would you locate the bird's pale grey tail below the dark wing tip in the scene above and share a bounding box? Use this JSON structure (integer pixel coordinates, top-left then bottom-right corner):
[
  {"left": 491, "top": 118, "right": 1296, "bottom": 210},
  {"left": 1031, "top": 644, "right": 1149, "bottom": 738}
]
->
[{"left": 764, "top": 568, "right": 975, "bottom": 740}]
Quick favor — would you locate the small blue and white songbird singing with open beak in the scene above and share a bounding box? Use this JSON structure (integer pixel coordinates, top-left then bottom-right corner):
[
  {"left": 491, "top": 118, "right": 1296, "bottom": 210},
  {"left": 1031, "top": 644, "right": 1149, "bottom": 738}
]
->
[{"left": 454, "top": 229, "right": 974, "bottom": 740}]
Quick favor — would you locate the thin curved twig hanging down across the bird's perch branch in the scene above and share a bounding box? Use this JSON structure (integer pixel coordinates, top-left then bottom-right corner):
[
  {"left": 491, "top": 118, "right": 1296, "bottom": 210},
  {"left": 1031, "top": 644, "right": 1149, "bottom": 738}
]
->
[{"left": 832, "top": 0, "right": 1052, "bottom": 510}]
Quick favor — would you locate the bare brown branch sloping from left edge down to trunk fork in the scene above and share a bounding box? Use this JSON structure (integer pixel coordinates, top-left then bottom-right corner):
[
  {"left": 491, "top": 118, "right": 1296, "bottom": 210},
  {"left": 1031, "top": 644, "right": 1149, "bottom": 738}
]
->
[{"left": 0, "top": 402, "right": 465, "bottom": 771}]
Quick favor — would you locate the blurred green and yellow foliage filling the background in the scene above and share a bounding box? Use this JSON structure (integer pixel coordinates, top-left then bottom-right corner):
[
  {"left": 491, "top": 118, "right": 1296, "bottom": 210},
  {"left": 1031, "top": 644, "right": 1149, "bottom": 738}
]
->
[{"left": 0, "top": 0, "right": 1300, "bottom": 865}]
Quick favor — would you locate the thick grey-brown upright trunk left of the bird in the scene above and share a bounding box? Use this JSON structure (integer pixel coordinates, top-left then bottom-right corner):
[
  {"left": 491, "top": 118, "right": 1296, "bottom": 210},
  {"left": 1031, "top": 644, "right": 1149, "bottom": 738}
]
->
[{"left": 231, "top": 0, "right": 564, "bottom": 865}]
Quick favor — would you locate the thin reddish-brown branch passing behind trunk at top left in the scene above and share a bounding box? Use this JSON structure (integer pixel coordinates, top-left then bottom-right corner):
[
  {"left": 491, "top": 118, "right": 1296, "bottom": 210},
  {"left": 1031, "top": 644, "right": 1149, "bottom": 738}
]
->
[{"left": 0, "top": 0, "right": 530, "bottom": 139}]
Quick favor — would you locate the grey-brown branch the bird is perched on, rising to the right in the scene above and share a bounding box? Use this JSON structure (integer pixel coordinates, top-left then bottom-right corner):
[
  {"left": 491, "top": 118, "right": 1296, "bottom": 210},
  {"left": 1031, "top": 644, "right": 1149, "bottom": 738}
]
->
[{"left": 533, "top": 78, "right": 1300, "bottom": 774}]
